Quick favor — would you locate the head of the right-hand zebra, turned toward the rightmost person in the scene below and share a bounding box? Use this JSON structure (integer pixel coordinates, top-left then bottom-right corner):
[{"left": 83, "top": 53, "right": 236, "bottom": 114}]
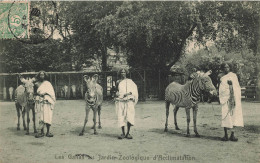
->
[{"left": 199, "top": 71, "right": 217, "bottom": 96}]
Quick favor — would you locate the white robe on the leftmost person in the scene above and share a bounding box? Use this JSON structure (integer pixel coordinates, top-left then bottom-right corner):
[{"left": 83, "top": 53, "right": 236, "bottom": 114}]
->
[{"left": 35, "top": 81, "right": 56, "bottom": 124}]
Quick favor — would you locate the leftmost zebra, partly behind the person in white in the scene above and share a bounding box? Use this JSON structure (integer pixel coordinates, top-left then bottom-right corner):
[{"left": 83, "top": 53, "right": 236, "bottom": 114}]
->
[{"left": 15, "top": 78, "right": 37, "bottom": 135}]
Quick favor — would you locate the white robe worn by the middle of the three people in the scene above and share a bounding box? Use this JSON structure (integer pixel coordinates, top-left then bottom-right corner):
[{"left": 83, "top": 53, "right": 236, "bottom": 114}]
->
[{"left": 115, "top": 79, "right": 138, "bottom": 127}]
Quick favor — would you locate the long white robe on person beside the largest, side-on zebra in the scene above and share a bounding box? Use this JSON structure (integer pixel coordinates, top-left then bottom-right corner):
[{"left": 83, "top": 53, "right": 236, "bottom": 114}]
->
[{"left": 219, "top": 72, "right": 244, "bottom": 128}]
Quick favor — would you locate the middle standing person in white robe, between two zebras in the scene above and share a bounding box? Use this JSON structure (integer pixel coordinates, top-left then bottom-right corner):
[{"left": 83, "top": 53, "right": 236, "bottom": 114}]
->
[{"left": 115, "top": 69, "right": 138, "bottom": 139}]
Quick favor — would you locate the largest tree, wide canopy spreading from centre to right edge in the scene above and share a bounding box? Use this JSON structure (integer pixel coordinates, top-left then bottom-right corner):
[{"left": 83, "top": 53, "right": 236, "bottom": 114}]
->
[{"left": 99, "top": 2, "right": 259, "bottom": 70}]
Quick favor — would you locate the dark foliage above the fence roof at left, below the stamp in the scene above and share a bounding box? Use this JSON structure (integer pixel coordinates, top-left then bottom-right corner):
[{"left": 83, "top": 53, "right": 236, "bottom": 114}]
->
[{"left": 0, "top": 39, "right": 68, "bottom": 73}]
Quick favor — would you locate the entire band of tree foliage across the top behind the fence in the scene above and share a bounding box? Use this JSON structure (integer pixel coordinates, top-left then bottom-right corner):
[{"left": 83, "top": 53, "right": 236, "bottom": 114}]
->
[{"left": 0, "top": 1, "right": 260, "bottom": 76}]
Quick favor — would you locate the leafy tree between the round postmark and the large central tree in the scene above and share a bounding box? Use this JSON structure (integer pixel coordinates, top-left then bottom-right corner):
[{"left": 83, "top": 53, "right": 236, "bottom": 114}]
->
[{"left": 59, "top": 2, "right": 121, "bottom": 71}]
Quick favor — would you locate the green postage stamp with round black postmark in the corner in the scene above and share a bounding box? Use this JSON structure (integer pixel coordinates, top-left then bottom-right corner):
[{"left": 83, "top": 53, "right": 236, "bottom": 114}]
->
[{"left": 0, "top": 1, "right": 58, "bottom": 44}]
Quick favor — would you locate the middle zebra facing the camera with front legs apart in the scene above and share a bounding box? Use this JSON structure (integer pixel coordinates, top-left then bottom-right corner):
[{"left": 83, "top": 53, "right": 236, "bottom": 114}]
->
[{"left": 79, "top": 74, "right": 103, "bottom": 136}]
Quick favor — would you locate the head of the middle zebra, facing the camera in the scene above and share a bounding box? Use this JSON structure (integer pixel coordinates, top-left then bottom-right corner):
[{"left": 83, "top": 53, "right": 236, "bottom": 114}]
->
[{"left": 84, "top": 74, "right": 98, "bottom": 106}]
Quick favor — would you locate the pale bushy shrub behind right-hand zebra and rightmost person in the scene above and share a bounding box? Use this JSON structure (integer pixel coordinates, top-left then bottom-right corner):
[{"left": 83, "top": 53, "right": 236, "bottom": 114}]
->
[{"left": 177, "top": 47, "right": 257, "bottom": 85}]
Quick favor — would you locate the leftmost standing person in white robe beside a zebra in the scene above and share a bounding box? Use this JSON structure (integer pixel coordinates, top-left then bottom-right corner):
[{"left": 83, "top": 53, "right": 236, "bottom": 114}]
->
[{"left": 35, "top": 71, "right": 56, "bottom": 138}]
